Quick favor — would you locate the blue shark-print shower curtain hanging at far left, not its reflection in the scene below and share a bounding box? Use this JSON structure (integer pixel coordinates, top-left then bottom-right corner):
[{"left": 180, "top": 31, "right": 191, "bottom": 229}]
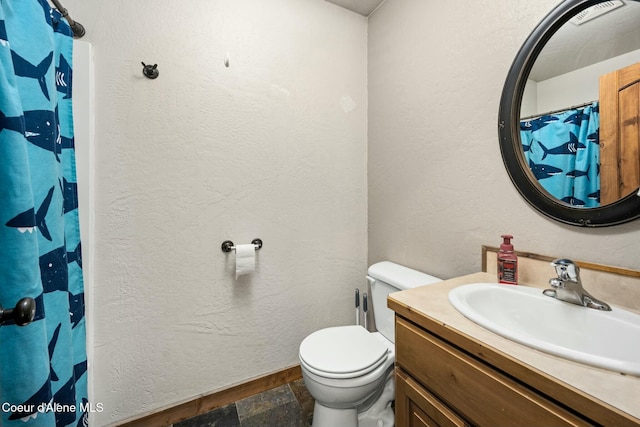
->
[{"left": 0, "top": 0, "right": 88, "bottom": 427}]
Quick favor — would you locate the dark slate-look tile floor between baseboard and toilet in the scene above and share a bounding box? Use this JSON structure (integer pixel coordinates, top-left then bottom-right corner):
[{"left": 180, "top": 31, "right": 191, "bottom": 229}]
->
[{"left": 173, "top": 380, "right": 314, "bottom": 427}]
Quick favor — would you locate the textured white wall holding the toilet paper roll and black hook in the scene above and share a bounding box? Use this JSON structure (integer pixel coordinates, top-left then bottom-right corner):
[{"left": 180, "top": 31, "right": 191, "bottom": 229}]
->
[{"left": 65, "top": 0, "right": 367, "bottom": 426}]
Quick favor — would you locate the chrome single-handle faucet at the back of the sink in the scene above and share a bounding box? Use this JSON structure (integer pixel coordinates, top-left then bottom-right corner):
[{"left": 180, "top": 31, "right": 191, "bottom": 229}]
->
[{"left": 543, "top": 259, "right": 611, "bottom": 311}]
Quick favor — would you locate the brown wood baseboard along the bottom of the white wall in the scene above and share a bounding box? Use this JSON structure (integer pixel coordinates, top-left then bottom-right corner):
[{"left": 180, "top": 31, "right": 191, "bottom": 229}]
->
[{"left": 119, "top": 365, "right": 302, "bottom": 427}]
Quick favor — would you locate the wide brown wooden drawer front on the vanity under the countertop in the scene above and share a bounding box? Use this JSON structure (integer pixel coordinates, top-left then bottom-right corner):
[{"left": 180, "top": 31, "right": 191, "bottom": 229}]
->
[{"left": 396, "top": 317, "right": 591, "bottom": 427}]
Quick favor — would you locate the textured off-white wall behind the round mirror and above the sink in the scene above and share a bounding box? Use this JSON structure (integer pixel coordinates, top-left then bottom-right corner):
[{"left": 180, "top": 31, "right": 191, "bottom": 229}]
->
[{"left": 368, "top": 0, "right": 640, "bottom": 277}]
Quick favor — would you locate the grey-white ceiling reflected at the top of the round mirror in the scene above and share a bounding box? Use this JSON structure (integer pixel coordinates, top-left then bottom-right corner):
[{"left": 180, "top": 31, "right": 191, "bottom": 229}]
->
[{"left": 529, "top": 1, "right": 640, "bottom": 82}]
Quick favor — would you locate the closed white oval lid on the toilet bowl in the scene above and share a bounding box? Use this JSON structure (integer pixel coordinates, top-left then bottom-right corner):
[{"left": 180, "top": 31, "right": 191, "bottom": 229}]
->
[{"left": 300, "top": 325, "right": 388, "bottom": 377}]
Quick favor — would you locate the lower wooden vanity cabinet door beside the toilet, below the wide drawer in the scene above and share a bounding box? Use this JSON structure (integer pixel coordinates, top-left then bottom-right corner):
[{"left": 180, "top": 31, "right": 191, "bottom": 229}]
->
[{"left": 396, "top": 369, "right": 468, "bottom": 427}]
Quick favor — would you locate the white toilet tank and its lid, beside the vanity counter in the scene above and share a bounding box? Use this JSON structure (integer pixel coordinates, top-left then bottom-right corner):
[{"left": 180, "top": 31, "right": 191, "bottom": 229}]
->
[{"left": 368, "top": 261, "right": 442, "bottom": 343}]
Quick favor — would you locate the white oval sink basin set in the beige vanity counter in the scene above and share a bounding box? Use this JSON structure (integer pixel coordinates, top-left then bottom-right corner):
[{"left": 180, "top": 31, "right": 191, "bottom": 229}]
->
[{"left": 449, "top": 283, "right": 640, "bottom": 376}]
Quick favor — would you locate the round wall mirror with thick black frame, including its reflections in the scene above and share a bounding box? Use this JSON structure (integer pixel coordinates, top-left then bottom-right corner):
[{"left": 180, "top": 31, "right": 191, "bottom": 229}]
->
[{"left": 498, "top": 0, "right": 640, "bottom": 227}]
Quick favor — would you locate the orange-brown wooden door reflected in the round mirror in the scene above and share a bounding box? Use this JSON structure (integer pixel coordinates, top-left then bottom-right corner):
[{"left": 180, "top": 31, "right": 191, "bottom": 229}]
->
[{"left": 600, "top": 63, "right": 640, "bottom": 205}]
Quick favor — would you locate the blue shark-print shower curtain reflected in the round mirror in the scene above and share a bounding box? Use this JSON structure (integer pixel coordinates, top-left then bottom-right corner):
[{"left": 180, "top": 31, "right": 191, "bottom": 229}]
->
[{"left": 520, "top": 101, "right": 600, "bottom": 207}]
